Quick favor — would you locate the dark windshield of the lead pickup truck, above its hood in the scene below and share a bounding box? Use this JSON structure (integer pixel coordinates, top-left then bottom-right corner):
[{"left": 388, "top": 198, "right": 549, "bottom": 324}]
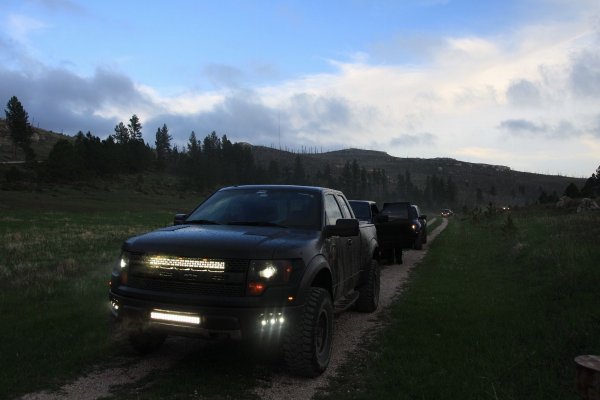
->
[{"left": 186, "top": 188, "right": 321, "bottom": 230}]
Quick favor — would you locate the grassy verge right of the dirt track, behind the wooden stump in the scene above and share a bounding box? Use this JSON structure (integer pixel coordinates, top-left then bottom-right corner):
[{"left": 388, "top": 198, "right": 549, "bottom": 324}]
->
[{"left": 316, "top": 209, "right": 600, "bottom": 399}]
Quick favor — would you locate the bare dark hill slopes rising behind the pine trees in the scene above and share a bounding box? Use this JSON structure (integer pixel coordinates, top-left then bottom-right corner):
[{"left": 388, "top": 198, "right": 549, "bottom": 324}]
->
[{"left": 0, "top": 119, "right": 585, "bottom": 208}]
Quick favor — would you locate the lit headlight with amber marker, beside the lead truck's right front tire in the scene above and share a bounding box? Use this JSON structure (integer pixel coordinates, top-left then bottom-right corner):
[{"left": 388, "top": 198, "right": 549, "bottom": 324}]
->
[{"left": 247, "top": 260, "right": 294, "bottom": 296}]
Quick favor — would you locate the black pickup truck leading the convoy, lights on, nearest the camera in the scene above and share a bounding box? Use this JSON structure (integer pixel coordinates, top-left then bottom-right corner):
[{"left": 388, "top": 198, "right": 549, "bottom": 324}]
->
[{"left": 109, "top": 185, "right": 380, "bottom": 376}]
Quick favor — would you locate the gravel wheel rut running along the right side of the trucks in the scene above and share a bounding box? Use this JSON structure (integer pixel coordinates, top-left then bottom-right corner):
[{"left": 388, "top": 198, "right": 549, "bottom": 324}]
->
[{"left": 255, "top": 218, "right": 448, "bottom": 400}]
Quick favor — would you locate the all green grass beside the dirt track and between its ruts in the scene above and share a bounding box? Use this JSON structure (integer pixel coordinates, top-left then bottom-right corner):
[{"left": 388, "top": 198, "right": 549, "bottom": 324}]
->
[{"left": 0, "top": 189, "right": 600, "bottom": 399}]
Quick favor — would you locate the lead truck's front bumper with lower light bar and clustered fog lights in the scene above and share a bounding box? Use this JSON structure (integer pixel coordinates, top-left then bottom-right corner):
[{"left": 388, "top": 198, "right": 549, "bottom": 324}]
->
[{"left": 109, "top": 291, "right": 302, "bottom": 339}]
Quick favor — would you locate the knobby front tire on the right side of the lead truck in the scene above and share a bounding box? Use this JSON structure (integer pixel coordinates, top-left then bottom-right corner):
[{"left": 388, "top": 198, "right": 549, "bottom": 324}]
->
[{"left": 283, "top": 287, "right": 333, "bottom": 378}]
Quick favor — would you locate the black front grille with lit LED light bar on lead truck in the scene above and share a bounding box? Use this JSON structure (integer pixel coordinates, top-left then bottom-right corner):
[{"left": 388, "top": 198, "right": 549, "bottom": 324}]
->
[{"left": 127, "top": 254, "right": 249, "bottom": 297}]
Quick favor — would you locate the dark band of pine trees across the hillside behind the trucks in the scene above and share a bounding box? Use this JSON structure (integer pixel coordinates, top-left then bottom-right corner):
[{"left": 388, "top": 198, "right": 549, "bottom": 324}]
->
[{"left": 3, "top": 97, "right": 600, "bottom": 209}]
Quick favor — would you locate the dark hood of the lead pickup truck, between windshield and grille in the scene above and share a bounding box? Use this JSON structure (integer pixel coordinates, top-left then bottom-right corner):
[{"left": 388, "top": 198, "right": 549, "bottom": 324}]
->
[{"left": 123, "top": 225, "right": 320, "bottom": 259}]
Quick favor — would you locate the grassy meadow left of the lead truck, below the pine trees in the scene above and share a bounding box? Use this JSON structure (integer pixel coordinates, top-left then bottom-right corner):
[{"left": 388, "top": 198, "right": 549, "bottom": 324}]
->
[{"left": 0, "top": 189, "right": 200, "bottom": 398}]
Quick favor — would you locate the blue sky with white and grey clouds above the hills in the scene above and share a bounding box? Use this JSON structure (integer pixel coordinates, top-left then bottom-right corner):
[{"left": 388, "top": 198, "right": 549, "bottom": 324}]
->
[{"left": 0, "top": 0, "right": 600, "bottom": 177}]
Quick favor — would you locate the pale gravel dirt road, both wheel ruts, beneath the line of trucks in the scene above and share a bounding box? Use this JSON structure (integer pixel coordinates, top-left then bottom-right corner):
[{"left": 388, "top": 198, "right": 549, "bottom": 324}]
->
[{"left": 21, "top": 219, "right": 448, "bottom": 400}]
